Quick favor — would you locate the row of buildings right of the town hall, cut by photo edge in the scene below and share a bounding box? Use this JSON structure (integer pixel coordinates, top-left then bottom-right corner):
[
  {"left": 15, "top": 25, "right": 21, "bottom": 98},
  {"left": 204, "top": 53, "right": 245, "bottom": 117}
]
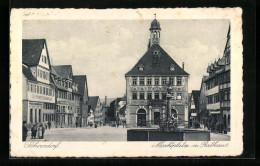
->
[{"left": 189, "top": 26, "right": 231, "bottom": 132}]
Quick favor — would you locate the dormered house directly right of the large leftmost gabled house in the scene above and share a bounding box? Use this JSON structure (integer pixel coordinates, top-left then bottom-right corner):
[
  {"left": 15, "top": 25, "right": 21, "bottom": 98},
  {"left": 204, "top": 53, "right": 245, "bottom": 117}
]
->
[{"left": 52, "top": 65, "right": 82, "bottom": 127}]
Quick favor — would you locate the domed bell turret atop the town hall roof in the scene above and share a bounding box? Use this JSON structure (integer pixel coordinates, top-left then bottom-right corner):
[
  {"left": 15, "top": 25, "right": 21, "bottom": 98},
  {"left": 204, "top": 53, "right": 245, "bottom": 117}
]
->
[{"left": 148, "top": 14, "right": 161, "bottom": 49}]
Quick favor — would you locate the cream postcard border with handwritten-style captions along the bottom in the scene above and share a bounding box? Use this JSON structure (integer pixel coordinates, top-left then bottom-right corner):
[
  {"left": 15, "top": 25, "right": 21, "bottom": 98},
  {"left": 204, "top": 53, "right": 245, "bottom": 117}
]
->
[{"left": 10, "top": 8, "right": 243, "bottom": 157}]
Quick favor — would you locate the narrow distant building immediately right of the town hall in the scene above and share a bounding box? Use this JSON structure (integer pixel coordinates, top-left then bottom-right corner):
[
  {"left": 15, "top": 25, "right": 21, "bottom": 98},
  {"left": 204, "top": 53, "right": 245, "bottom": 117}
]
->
[{"left": 189, "top": 90, "right": 200, "bottom": 127}]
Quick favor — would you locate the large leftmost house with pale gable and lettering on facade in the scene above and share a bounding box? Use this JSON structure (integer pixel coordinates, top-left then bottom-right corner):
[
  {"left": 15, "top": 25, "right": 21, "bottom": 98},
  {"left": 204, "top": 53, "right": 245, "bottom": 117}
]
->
[{"left": 22, "top": 39, "right": 56, "bottom": 127}]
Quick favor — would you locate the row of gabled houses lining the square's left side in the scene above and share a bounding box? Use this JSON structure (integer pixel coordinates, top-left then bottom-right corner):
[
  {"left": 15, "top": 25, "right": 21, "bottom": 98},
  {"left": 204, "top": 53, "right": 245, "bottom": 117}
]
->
[{"left": 22, "top": 39, "right": 101, "bottom": 127}]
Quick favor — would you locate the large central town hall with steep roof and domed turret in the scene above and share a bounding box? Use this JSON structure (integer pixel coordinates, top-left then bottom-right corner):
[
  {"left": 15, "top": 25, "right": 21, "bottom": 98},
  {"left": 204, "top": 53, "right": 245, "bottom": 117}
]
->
[{"left": 125, "top": 19, "right": 189, "bottom": 127}]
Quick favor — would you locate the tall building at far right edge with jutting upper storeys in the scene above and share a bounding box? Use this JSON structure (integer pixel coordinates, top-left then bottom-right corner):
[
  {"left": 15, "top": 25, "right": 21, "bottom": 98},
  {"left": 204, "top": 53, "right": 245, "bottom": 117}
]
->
[{"left": 204, "top": 24, "right": 230, "bottom": 131}]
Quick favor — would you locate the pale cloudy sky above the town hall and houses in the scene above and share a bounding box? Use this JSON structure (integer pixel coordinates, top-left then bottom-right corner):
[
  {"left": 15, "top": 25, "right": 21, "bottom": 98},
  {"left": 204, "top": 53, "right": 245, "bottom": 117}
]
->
[{"left": 23, "top": 18, "right": 229, "bottom": 98}]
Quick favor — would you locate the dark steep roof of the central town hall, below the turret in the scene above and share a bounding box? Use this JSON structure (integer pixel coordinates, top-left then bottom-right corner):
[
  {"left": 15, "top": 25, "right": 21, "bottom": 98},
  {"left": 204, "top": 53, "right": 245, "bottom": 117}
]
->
[{"left": 125, "top": 44, "right": 189, "bottom": 76}]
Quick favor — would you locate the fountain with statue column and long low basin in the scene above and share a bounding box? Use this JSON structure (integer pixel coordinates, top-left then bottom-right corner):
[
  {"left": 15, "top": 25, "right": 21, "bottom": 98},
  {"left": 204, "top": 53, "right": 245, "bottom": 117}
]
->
[{"left": 127, "top": 83, "right": 210, "bottom": 141}]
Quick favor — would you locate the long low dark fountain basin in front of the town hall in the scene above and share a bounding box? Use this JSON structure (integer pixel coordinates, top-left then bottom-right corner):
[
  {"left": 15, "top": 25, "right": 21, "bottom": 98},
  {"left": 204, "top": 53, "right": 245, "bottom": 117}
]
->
[{"left": 127, "top": 129, "right": 210, "bottom": 141}]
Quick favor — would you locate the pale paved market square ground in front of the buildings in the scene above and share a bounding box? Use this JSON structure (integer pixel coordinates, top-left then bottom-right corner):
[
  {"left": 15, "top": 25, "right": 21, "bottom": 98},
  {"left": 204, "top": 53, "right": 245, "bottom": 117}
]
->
[{"left": 27, "top": 126, "right": 230, "bottom": 141}]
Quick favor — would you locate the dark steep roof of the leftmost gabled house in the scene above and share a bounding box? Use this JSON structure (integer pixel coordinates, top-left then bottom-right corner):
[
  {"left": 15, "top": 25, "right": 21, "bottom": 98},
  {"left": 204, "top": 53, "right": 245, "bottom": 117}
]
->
[{"left": 22, "top": 39, "right": 46, "bottom": 66}]
